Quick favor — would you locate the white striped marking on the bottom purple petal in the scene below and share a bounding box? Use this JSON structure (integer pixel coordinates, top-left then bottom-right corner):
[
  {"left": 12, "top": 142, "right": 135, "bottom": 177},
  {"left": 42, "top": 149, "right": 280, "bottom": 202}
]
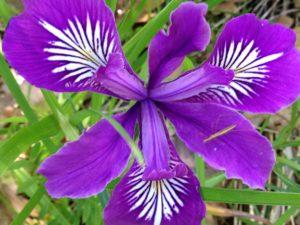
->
[{"left": 124, "top": 168, "right": 188, "bottom": 225}]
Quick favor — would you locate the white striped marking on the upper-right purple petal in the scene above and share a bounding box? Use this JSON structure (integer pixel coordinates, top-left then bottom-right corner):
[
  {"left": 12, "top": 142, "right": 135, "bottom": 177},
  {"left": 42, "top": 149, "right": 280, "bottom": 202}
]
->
[{"left": 199, "top": 40, "right": 283, "bottom": 105}]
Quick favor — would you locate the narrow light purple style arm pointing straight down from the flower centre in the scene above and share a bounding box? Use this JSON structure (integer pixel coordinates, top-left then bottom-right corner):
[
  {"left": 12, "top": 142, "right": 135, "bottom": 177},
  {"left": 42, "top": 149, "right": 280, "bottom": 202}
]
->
[{"left": 141, "top": 100, "right": 173, "bottom": 179}]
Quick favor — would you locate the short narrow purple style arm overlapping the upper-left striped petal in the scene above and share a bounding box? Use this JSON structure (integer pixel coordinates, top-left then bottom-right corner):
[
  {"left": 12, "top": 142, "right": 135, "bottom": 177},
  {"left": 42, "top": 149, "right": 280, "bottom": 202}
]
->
[{"left": 97, "top": 53, "right": 147, "bottom": 100}]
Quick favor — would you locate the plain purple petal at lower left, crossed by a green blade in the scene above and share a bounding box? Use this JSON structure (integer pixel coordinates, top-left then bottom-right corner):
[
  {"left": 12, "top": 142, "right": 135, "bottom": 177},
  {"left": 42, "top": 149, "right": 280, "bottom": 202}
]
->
[{"left": 38, "top": 106, "right": 137, "bottom": 198}]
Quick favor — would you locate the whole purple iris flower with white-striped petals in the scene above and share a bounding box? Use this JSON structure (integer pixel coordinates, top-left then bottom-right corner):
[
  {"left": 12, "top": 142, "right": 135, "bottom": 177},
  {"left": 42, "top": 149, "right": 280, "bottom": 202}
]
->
[{"left": 3, "top": 0, "right": 300, "bottom": 225}]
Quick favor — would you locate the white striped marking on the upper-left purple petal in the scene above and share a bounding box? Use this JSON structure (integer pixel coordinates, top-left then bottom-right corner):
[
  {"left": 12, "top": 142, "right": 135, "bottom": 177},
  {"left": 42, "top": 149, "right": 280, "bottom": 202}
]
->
[{"left": 39, "top": 15, "right": 117, "bottom": 87}]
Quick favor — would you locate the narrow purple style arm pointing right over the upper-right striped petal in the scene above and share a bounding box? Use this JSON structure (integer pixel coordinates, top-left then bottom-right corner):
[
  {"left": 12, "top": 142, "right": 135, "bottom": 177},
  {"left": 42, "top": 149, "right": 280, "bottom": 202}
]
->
[{"left": 149, "top": 64, "right": 233, "bottom": 102}]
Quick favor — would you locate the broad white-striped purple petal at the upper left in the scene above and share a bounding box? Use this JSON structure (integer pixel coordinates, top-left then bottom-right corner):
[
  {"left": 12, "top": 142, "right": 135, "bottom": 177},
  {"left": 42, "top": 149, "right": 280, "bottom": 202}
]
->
[{"left": 3, "top": 0, "right": 132, "bottom": 92}]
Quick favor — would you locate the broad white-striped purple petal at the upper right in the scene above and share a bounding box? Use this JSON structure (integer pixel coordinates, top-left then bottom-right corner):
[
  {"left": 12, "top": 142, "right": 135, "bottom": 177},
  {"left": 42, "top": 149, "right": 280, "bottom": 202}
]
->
[{"left": 194, "top": 14, "right": 300, "bottom": 113}]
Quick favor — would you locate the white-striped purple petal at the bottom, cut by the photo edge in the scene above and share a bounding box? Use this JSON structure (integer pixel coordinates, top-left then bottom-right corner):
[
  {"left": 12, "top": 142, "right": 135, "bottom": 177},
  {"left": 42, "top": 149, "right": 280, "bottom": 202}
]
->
[{"left": 104, "top": 143, "right": 205, "bottom": 225}]
